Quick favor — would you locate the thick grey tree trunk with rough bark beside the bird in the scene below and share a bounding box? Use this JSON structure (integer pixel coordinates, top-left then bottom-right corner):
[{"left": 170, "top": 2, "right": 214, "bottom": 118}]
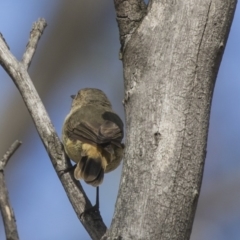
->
[{"left": 103, "top": 0, "right": 237, "bottom": 240}]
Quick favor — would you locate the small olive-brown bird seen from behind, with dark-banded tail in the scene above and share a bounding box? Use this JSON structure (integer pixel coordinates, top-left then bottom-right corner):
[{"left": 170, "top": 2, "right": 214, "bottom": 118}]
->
[{"left": 62, "top": 88, "right": 124, "bottom": 213}]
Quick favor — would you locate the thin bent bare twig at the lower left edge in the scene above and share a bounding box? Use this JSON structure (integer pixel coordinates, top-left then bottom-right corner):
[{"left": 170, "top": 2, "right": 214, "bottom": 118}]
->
[{"left": 0, "top": 140, "right": 22, "bottom": 240}]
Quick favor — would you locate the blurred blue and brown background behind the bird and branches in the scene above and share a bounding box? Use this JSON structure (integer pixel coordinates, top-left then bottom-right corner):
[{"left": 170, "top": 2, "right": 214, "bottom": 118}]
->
[{"left": 0, "top": 0, "right": 240, "bottom": 240}]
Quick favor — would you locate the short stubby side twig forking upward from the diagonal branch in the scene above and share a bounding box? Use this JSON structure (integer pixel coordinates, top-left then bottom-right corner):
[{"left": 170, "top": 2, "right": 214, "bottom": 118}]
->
[{"left": 22, "top": 18, "right": 47, "bottom": 69}]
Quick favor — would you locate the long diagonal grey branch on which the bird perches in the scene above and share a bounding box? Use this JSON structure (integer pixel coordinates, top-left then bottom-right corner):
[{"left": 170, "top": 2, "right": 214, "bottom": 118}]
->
[{"left": 0, "top": 20, "right": 107, "bottom": 239}]
